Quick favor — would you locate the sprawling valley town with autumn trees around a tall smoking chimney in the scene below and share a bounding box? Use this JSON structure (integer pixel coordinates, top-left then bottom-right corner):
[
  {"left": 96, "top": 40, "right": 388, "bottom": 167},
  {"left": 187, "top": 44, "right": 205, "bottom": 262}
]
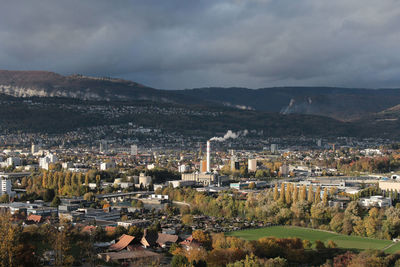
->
[{"left": 0, "top": 131, "right": 400, "bottom": 266}]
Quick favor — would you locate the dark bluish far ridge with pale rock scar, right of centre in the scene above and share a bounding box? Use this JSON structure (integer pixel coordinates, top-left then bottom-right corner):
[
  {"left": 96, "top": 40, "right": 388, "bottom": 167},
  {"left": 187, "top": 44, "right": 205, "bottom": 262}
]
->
[{"left": 175, "top": 87, "right": 400, "bottom": 120}]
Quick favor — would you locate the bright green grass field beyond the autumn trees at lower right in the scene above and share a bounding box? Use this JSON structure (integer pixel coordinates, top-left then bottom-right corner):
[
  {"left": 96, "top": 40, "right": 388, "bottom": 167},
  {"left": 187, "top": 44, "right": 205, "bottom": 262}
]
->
[{"left": 226, "top": 226, "right": 400, "bottom": 253}]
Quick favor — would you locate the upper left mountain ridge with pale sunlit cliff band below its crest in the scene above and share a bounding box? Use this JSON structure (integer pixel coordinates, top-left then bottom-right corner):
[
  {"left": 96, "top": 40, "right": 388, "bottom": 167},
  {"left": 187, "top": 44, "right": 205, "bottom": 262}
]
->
[{"left": 0, "top": 70, "right": 200, "bottom": 103}]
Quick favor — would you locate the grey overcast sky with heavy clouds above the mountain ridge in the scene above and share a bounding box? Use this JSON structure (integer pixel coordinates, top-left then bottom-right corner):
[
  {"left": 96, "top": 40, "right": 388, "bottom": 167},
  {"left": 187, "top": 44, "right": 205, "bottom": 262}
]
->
[{"left": 0, "top": 0, "right": 400, "bottom": 89}]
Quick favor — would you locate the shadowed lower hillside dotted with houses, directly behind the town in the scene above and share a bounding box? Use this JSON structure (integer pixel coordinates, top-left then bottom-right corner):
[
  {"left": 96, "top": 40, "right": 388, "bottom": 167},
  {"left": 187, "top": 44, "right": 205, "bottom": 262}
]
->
[{"left": 0, "top": 94, "right": 358, "bottom": 137}]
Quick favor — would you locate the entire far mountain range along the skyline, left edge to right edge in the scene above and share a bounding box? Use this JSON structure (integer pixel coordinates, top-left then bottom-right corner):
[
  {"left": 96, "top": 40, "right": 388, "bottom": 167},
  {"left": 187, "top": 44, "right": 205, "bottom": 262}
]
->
[{"left": 0, "top": 70, "right": 400, "bottom": 121}]
